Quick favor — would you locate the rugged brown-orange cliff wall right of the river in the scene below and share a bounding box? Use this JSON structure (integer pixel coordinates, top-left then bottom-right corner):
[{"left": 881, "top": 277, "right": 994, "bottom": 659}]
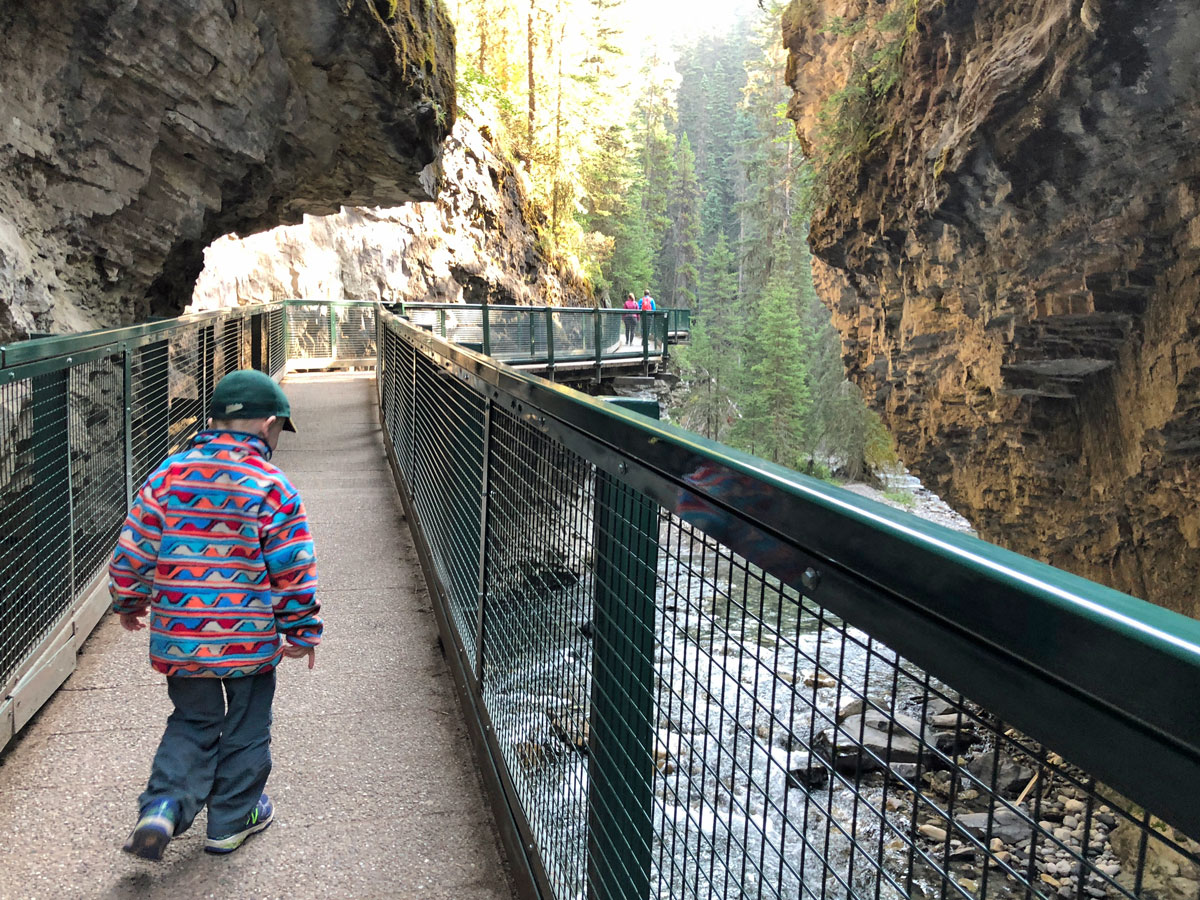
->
[{"left": 784, "top": 0, "right": 1200, "bottom": 616}]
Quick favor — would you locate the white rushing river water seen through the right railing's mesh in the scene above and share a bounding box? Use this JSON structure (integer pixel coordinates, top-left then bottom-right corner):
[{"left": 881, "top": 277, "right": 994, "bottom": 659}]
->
[{"left": 485, "top": 508, "right": 969, "bottom": 898}]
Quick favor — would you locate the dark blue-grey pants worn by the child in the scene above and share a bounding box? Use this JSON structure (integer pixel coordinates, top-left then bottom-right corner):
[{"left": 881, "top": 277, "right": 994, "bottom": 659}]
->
[{"left": 138, "top": 670, "right": 275, "bottom": 838}]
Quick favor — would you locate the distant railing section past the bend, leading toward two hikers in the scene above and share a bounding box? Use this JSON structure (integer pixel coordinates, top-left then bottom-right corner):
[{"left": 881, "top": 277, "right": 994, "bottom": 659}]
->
[{"left": 396, "top": 304, "right": 672, "bottom": 374}]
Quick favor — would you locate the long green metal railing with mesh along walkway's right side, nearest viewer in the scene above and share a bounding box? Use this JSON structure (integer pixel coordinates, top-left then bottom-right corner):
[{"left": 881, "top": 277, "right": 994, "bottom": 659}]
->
[{"left": 379, "top": 313, "right": 1200, "bottom": 900}]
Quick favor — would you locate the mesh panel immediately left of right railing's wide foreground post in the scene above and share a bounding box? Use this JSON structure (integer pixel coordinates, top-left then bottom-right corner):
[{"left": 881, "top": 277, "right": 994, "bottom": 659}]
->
[{"left": 481, "top": 408, "right": 594, "bottom": 896}]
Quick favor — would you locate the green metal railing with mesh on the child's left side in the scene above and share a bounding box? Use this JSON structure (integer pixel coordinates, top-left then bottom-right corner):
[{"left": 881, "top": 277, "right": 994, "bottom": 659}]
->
[{"left": 0, "top": 304, "right": 297, "bottom": 745}]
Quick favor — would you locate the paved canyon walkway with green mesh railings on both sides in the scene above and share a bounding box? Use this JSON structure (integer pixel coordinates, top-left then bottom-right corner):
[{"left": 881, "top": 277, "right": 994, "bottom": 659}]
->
[{"left": 0, "top": 302, "right": 1200, "bottom": 900}]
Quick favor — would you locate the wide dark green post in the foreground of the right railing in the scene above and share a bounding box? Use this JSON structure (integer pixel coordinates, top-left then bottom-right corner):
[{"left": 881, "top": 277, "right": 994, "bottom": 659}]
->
[{"left": 588, "top": 400, "right": 659, "bottom": 900}]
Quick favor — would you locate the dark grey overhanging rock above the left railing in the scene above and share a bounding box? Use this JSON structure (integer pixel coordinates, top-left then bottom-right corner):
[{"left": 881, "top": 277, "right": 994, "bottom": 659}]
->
[{"left": 0, "top": 0, "right": 455, "bottom": 342}]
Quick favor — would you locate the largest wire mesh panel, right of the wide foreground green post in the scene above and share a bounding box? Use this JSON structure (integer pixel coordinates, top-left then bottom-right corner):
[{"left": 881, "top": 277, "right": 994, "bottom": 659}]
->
[{"left": 638, "top": 518, "right": 1200, "bottom": 898}]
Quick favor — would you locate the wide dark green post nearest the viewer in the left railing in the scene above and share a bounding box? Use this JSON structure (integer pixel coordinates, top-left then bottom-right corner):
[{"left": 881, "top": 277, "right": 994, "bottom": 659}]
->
[{"left": 29, "top": 369, "right": 76, "bottom": 610}]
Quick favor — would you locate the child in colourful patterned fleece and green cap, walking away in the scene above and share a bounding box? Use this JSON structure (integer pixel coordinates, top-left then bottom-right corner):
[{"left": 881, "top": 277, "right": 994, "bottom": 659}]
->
[{"left": 108, "top": 370, "right": 324, "bottom": 859}]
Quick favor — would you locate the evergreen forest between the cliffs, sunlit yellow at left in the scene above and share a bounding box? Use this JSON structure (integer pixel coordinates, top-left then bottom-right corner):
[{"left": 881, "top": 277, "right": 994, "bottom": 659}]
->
[{"left": 449, "top": 0, "right": 895, "bottom": 480}]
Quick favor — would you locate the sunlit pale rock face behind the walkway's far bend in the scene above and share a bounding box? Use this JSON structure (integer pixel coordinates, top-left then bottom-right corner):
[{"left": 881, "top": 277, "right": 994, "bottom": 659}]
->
[{"left": 193, "top": 114, "right": 592, "bottom": 310}]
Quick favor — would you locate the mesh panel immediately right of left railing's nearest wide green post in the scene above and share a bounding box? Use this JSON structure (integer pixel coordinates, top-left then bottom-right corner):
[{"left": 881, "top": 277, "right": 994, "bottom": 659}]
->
[{"left": 68, "top": 355, "right": 127, "bottom": 600}]
